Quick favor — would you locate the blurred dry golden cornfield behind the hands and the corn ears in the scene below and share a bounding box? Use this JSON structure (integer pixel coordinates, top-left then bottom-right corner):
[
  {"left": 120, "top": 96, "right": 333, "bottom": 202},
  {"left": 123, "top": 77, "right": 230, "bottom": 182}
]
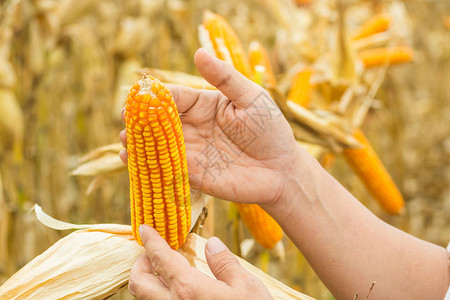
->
[{"left": 0, "top": 0, "right": 450, "bottom": 299}]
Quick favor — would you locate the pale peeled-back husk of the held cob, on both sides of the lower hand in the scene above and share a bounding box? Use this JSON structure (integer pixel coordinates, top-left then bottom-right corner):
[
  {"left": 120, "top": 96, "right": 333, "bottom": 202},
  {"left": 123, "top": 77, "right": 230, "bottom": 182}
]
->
[{"left": 0, "top": 206, "right": 312, "bottom": 299}]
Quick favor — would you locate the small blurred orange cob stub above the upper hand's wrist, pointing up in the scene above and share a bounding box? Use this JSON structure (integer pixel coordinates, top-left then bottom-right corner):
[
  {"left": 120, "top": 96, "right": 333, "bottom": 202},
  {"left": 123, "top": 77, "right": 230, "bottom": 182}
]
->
[{"left": 287, "top": 68, "right": 312, "bottom": 107}]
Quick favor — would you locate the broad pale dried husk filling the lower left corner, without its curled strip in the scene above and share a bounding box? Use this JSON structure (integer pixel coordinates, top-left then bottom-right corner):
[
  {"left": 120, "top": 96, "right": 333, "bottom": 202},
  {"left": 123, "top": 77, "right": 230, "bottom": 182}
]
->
[{"left": 0, "top": 224, "right": 144, "bottom": 299}]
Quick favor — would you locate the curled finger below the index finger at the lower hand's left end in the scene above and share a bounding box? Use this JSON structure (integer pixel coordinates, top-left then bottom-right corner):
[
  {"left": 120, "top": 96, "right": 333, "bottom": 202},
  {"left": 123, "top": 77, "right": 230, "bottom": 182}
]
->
[{"left": 128, "top": 254, "right": 170, "bottom": 299}]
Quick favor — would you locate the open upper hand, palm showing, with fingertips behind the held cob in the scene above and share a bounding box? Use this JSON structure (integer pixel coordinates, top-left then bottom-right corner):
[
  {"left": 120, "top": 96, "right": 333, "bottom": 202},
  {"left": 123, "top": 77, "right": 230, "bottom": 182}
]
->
[{"left": 120, "top": 49, "right": 298, "bottom": 204}]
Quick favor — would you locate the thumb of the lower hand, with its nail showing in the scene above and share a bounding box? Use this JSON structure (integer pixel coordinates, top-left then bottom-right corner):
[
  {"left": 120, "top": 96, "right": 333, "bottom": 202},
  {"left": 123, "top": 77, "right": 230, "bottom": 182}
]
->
[{"left": 205, "top": 237, "right": 247, "bottom": 286}]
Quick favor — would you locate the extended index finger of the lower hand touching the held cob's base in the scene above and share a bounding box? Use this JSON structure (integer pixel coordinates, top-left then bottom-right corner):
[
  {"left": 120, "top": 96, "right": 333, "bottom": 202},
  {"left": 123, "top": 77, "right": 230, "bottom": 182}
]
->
[{"left": 139, "top": 225, "right": 192, "bottom": 286}]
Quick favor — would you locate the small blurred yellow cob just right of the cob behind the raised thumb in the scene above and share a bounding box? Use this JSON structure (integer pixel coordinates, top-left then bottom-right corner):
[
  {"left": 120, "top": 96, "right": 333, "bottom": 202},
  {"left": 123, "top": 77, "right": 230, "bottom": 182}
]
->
[{"left": 248, "top": 41, "right": 277, "bottom": 87}]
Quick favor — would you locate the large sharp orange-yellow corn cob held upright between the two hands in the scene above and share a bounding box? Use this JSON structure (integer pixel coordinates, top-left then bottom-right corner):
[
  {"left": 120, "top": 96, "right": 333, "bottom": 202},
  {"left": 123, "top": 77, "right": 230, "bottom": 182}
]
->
[{"left": 125, "top": 75, "right": 191, "bottom": 249}]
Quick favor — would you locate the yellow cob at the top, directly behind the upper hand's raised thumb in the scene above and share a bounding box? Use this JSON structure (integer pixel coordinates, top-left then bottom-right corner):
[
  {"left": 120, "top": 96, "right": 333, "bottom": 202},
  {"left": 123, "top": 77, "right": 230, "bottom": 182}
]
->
[{"left": 201, "top": 10, "right": 252, "bottom": 78}]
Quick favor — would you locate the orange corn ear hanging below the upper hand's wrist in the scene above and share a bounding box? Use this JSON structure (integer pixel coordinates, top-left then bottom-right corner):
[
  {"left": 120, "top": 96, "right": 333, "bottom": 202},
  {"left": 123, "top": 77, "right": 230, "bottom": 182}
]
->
[{"left": 236, "top": 203, "right": 283, "bottom": 249}]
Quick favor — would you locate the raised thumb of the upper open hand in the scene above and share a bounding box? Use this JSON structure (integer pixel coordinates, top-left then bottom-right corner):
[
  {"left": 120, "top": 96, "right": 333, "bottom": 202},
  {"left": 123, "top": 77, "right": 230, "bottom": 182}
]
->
[{"left": 194, "top": 48, "right": 264, "bottom": 108}]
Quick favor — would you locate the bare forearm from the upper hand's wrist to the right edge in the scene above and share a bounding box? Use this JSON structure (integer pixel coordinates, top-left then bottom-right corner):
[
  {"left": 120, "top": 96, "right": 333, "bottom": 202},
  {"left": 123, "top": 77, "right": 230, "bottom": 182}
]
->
[{"left": 264, "top": 145, "right": 449, "bottom": 299}]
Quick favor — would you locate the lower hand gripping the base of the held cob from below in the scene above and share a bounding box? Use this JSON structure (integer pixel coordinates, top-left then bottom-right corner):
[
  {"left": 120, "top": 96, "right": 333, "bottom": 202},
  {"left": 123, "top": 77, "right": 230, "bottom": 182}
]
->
[{"left": 128, "top": 225, "right": 272, "bottom": 299}]
